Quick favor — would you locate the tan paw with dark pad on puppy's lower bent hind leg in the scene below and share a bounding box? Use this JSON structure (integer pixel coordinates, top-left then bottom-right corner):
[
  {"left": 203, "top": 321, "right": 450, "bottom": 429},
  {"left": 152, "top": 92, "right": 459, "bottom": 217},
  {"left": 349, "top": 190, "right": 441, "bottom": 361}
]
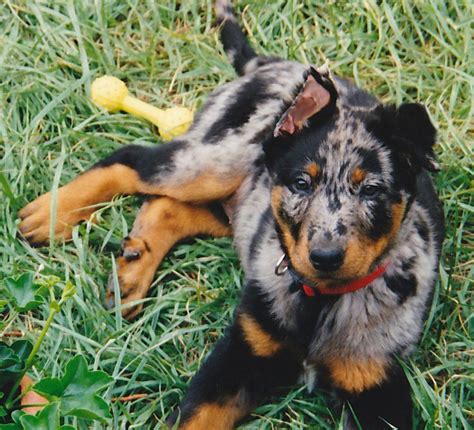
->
[{"left": 105, "top": 237, "right": 156, "bottom": 320}]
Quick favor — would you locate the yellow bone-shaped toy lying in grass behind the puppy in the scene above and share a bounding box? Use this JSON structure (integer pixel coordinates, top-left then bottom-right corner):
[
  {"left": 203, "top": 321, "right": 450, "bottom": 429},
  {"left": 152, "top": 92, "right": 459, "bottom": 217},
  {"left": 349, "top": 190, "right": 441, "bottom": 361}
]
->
[{"left": 91, "top": 75, "right": 193, "bottom": 140}]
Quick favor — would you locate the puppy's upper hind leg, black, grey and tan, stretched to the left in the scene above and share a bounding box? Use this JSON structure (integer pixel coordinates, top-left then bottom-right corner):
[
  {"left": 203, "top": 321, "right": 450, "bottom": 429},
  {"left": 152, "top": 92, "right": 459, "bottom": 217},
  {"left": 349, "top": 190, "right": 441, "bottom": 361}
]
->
[{"left": 19, "top": 140, "right": 247, "bottom": 245}]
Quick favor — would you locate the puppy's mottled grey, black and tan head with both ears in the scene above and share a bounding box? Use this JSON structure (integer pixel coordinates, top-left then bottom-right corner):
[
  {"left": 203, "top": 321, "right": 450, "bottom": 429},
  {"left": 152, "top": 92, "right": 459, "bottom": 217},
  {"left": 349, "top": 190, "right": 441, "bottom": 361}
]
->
[{"left": 265, "top": 69, "right": 436, "bottom": 286}]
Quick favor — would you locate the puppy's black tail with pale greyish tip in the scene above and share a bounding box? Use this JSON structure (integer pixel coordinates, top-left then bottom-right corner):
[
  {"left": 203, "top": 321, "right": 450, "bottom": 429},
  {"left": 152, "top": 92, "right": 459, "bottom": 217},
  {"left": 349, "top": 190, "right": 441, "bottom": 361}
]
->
[{"left": 216, "top": 0, "right": 267, "bottom": 76}]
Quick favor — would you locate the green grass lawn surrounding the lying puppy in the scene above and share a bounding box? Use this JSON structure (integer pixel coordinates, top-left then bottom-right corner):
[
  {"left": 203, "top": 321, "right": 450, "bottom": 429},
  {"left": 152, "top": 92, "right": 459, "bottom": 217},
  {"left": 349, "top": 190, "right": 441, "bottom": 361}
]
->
[{"left": 0, "top": 0, "right": 474, "bottom": 429}]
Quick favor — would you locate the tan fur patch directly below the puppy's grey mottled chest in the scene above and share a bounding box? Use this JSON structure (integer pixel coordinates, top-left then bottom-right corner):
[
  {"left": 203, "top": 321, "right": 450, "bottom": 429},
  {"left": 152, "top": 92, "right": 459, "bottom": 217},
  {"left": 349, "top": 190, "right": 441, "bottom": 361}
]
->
[{"left": 327, "top": 359, "right": 387, "bottom": 393}]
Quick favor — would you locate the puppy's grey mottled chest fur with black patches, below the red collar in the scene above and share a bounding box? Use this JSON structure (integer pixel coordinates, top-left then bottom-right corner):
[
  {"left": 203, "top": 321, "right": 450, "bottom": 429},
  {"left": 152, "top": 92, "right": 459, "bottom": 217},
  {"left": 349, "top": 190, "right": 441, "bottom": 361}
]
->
[{"left": 307, "top": 238, "right": 436, "bottom": 363}]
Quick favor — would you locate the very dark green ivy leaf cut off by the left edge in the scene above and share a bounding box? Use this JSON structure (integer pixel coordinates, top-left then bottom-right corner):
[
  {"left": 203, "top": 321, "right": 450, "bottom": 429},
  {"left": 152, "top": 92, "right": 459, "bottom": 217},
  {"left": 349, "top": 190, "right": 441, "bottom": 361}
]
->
[{"left": 0, "top": 340, "right": 33, "bottom": 387}]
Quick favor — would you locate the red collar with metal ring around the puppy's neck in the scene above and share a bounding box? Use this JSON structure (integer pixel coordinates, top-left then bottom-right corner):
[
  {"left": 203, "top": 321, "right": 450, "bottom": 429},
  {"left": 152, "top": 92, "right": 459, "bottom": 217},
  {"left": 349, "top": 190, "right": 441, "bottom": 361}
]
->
[{"left": 275, "top": 255, "right": 390, "bottom": 297}]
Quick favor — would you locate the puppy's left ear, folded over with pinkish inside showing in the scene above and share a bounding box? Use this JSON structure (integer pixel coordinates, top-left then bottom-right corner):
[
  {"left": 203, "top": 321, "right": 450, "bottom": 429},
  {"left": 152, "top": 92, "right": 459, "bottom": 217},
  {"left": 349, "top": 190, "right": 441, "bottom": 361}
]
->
[{"left": 273, "top": 66, "right": 337, "bottom": 137}]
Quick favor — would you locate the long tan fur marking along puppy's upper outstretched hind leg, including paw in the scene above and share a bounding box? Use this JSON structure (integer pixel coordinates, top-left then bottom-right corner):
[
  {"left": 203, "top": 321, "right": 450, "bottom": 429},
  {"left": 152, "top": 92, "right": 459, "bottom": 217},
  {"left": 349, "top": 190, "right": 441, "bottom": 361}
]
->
[{"left": 19, "top": 164, "right": 243, "bottom": 244}]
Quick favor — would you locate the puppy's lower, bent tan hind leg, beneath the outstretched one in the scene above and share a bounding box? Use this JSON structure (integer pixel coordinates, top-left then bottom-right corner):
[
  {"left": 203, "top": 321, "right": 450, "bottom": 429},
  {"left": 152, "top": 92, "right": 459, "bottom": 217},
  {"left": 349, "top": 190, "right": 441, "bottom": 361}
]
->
[{"left": 107, "top": 197, "right": 232, "bottom": 318}]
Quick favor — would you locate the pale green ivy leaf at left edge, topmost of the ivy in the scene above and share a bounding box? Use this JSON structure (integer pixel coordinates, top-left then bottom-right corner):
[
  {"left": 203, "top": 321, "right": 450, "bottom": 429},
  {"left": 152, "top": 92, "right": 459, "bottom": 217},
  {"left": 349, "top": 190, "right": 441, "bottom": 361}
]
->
[{"left": 4, "top": 273, "right": 45, "bottom": 312}]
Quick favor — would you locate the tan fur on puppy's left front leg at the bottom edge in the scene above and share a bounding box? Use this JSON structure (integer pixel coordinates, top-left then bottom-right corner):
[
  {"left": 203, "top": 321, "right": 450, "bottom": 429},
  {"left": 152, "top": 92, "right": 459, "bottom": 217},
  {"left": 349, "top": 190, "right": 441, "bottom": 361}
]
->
[{"left": 179, "top": 398, "right": 249, "bottom": 430}]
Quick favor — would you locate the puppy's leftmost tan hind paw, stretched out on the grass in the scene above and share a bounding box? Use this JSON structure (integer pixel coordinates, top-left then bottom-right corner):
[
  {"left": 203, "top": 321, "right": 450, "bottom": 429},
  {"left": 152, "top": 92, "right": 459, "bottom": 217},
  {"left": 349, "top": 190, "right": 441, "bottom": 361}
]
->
[{"left": 18, "top": 190, "right": 94, "bottom": 246}]
